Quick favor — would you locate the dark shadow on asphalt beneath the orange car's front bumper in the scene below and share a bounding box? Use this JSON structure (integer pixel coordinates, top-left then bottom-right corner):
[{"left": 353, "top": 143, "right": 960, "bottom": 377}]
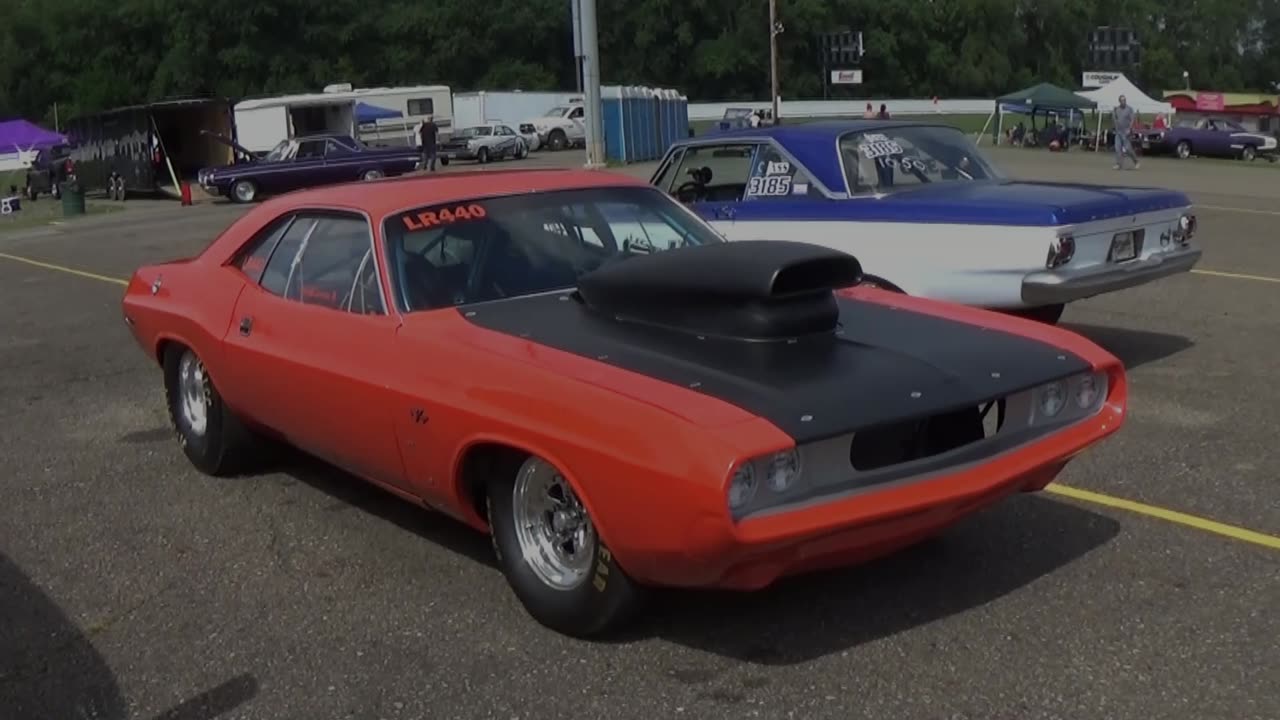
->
[{"left": 641, "top": 496, "right": 1120, "bottom": 661}]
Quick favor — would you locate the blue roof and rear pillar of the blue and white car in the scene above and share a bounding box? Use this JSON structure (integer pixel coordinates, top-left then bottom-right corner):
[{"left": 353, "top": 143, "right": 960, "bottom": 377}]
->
[{"left": 676, "top": 119, "right": 952, "bottom": 192}]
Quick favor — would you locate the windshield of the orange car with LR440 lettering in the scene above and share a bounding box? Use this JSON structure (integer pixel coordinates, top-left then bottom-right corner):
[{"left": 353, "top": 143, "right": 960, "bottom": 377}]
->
[{"left": 384, "top": 187, "right": 723, "bottom": 313}]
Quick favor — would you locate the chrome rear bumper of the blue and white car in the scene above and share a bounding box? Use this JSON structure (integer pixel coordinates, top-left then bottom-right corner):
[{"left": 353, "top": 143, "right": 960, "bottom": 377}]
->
[{"left": 1021, "top": 245, "right": 1203, "bottom": 306}]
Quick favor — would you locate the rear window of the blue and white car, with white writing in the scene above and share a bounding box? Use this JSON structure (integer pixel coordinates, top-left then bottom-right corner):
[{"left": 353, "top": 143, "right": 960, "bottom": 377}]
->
[{"left": 840, "top": 126, "right": 1004, "bottom": 195}]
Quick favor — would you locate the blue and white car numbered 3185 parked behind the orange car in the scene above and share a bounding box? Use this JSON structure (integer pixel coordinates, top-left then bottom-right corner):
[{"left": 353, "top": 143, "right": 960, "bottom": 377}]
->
[{"left": 650, "top": 120, "right": 1201, "bottom": 323}]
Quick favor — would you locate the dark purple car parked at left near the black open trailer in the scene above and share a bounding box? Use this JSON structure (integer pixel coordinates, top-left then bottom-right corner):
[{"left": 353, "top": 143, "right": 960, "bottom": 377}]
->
[{"left": 198, "top": 133, "right": 419, "bottom": 202}]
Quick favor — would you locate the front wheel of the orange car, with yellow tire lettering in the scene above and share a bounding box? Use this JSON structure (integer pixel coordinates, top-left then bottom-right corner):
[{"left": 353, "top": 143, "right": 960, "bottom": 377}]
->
[{"left": 486, "top": 456, "right": 641, "bottom": 638}]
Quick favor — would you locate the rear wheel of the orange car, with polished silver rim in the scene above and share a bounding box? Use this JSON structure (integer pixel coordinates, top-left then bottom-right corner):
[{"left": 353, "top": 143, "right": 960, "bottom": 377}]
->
[{"left": 164, "top": 345, "right": 255, "bottom": 477}]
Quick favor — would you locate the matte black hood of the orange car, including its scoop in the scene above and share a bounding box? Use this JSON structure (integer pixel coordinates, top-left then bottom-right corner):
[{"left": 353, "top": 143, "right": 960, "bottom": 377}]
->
[{"left": 460, "top": 241, "right": 1089, "bottom": 443}]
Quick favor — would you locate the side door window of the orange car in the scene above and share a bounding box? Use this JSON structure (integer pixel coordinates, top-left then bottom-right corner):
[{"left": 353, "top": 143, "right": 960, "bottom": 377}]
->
[{"left": 254, "top": 214, "right": 387, "bottom": 315}]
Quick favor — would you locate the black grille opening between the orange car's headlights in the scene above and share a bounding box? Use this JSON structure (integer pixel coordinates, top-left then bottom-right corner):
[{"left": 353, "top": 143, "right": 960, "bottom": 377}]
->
[{"left": 849, "top": 398, "right": 1006, "bottom": 473}]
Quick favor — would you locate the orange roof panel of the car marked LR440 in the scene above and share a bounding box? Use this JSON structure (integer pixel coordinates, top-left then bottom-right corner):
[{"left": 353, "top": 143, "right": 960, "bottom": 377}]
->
[{"left": 262, "top": 169, "right": 649, "bottom": 222}]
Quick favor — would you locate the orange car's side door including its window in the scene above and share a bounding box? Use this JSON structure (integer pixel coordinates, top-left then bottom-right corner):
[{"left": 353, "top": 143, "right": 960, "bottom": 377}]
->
[{"left": 215, "top": 210, "right": 404, "bottom": 486}]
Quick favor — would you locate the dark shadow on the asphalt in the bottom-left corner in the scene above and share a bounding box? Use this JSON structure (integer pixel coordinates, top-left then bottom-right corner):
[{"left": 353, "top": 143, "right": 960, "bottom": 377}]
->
[{"left": 0, "top": 553, "right": 259, "bottom": 720}]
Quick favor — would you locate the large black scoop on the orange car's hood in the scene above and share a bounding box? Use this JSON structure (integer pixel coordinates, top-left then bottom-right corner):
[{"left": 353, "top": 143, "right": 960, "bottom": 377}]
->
[{"left": 576, "top": 241, "right": 863, "bottom": 341}]
